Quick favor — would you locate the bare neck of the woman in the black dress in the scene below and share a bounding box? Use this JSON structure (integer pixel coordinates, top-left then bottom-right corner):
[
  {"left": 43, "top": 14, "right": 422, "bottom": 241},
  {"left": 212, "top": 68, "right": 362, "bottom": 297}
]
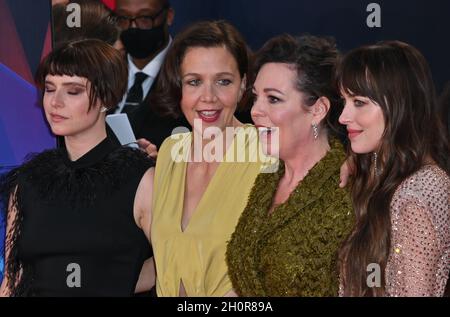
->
[{"left": 64, "top": 124, "right": 107, "bottom": 161}]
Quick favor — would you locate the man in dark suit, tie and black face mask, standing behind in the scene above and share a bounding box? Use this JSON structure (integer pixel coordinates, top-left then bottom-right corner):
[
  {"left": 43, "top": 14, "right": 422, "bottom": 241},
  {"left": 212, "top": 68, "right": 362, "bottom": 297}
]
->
[{"left": 114, "top": 0, "right": 188, "bottom": 149}]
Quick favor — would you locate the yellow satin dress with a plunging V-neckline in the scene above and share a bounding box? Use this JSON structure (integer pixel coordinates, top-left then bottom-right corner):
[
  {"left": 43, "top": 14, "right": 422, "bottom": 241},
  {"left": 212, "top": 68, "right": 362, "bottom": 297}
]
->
[{"left": 151, "top": 125, "right": 273, "bottom": 297}]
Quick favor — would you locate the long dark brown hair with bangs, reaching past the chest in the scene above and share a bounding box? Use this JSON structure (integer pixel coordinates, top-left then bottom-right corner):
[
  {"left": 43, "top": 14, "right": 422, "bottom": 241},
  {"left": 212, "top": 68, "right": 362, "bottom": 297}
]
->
[{"left": 336, "top": 41, "right": 450, "bottom": 296}]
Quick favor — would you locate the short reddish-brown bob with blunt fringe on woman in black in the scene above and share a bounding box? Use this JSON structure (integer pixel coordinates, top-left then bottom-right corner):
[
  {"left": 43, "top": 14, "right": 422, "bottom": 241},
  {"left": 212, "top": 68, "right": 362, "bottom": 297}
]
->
[{"left": 35, "top": 39, "right": 128, "bottom": 110}]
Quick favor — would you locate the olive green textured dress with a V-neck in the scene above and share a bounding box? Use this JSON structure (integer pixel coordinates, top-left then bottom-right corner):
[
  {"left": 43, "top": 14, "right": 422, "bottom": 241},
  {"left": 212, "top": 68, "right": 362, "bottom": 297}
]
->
[{"left": 226, "top": 140, "right": 354, "bottom": 296}]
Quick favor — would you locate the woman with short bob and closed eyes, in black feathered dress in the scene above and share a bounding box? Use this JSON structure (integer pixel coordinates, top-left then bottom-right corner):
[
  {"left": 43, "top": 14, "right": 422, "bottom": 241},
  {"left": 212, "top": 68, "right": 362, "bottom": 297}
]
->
[{"left": 0, "top": 40, "right": 153, "bottom": 296}]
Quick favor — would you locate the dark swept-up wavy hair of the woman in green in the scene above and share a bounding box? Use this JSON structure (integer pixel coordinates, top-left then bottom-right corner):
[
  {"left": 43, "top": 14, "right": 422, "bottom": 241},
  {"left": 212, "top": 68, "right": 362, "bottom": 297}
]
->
[{"left": 252, "top": 34, "right": 344, "bottom": 136}]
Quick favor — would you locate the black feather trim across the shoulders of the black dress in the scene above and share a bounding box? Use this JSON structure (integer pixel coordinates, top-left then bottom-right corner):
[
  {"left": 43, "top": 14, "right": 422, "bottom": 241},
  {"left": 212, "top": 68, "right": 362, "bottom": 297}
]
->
[{"left": 0, "top": 147, "right": 155, "bottom": 296}]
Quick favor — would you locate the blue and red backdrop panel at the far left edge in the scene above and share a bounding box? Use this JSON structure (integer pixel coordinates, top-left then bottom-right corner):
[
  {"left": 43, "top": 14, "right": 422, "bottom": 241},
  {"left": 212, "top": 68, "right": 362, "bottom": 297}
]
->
[{"left": 0, "top": 0, "right": 55, "bottom": 281}]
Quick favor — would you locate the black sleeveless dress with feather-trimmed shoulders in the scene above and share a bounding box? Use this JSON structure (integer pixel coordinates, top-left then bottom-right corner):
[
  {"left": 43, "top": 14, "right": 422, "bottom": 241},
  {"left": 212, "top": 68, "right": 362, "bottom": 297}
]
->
[{"left": 0, "top": 138, "right": 154, "bottom": 296}]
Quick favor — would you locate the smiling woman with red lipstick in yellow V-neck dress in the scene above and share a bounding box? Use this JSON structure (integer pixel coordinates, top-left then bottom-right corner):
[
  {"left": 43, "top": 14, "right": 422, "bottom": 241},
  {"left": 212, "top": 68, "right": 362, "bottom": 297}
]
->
[{"left": 151, "top": 21, "right": 274, "bottom": 296}]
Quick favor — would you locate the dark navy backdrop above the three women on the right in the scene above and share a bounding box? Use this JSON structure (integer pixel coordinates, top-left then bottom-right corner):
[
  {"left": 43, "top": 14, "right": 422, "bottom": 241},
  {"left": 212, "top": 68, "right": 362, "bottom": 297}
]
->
[{"left": 171, "top": 0, "right": 450, "bottom": 91}]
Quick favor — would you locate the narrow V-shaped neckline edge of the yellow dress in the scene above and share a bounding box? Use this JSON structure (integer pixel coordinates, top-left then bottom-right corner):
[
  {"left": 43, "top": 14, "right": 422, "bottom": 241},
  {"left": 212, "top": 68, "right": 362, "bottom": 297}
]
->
[{"left": 178, "top": 125, "right": 239, "bottom": 234}]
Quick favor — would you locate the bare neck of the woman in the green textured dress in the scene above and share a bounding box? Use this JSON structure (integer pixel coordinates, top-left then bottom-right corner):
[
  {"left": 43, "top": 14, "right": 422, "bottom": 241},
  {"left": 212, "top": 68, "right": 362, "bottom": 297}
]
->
[{"left": 280, "top": 135, "right": 330, "bottom": 186}]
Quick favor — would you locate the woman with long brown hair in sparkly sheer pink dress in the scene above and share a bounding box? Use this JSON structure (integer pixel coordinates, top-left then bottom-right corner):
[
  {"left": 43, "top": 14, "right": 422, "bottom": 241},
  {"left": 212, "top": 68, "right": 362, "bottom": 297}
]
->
[{"left": 337, "top": 41, "right": 450, "bottom": 296}]
